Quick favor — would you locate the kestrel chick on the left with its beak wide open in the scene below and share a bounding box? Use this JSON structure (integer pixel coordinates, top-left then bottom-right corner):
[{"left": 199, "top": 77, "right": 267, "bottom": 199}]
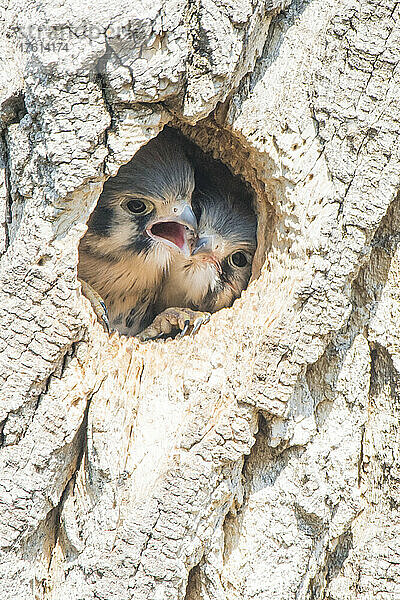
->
[{"left": 78, "top": 129, "right": 197, "bottom": 335}]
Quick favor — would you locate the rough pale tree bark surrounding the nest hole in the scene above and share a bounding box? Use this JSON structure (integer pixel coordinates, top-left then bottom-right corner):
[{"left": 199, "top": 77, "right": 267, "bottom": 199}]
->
[{"left": 0, "top": 0, "right": 400, "bottom": 600}]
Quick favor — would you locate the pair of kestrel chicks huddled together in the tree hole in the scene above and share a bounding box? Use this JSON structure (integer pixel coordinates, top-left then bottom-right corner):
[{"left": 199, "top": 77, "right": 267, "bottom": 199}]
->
[{"left": 79, "top": 128, "right": 257, "bottom": 341}]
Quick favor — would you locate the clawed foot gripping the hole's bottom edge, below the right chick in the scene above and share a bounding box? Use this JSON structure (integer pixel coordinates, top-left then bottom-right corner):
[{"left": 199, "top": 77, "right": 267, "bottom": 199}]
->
[{"left": 136, "top": 307, "right": 211, "bottom": 342}]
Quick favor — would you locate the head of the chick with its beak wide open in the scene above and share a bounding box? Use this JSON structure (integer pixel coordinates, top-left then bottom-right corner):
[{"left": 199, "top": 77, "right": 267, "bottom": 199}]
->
[{"left": 88, "top": 131, "right": 197, "bottom": 266}]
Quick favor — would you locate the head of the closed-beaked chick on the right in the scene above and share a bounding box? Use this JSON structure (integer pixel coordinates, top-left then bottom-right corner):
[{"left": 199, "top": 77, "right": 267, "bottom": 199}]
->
[{"left": 190, "top": 188, "right": 256, "bottom": 310}]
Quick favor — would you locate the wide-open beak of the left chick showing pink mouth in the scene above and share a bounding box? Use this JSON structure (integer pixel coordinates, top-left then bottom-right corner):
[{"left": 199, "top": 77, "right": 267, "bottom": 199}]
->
[{"left": 146, "top": 204, "right": 197, "bottom": 257}]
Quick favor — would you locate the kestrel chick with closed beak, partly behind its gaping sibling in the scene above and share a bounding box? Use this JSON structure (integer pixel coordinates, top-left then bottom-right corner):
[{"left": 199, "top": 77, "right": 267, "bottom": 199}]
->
[{"left": 139, "top": 186, "right": 257, "bottom": 341}]
